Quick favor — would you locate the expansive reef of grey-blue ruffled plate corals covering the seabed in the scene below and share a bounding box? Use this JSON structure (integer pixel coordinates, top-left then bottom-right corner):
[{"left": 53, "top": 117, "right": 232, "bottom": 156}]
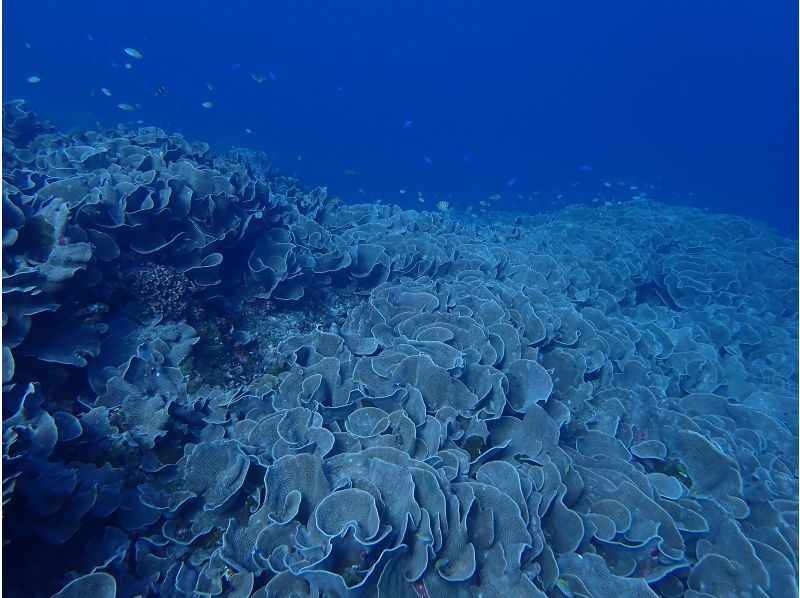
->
[{"left": 3, "top": 101, "right": 798, "bottom": 598}]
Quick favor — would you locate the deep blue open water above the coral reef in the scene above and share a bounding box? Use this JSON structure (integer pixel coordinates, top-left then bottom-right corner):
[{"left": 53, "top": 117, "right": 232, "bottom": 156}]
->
[{"left": 3, "top": 0, "right": 798, "bottom": 236}]
